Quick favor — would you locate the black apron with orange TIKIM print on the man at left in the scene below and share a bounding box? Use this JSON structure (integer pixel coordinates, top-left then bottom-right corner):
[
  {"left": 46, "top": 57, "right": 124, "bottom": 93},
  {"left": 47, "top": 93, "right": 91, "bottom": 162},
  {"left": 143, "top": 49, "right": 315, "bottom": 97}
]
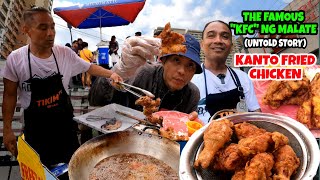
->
[{"left": 24, "top": 47, "right": 79, "bottom": 167}]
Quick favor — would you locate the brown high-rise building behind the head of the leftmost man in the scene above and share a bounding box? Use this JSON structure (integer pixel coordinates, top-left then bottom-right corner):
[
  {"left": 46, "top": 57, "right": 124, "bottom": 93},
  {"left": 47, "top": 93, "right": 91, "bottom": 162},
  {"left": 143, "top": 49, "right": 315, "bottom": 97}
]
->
[{"left": 0, "top": 0, "right": 53, "bottom": 59}]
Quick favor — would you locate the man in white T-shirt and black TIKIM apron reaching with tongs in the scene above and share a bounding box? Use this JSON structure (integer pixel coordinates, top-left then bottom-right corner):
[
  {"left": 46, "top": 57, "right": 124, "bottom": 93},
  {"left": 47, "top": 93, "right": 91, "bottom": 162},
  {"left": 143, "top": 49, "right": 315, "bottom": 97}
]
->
[{"left": 2, "top": 7, "right": 122, "bottom": 174}]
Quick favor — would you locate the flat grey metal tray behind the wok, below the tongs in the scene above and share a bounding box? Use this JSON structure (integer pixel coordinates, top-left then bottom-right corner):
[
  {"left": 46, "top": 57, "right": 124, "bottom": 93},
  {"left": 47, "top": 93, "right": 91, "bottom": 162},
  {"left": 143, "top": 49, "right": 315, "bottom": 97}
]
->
[{"left": 73, "top": 104, "right": 145, "bottom": 134}]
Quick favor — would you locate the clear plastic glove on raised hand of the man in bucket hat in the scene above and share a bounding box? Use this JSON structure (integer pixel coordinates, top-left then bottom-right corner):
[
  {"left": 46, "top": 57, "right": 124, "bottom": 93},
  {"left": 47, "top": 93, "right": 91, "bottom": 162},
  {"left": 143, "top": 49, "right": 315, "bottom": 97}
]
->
[{"left": 112, "top": 36, "right": 161, "bottom": 80}]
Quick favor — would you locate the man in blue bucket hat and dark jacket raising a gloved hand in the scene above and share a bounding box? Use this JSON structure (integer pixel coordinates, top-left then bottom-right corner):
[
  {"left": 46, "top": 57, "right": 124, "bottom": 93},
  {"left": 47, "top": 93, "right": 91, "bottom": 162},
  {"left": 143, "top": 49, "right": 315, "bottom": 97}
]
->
[{"left": 88, "top": 34, "right": 202, "bottom": 114}]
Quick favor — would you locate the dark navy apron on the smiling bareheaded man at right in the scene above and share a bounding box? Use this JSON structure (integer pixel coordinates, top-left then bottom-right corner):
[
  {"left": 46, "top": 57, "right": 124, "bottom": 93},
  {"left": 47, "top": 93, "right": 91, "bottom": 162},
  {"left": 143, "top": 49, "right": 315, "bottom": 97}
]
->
[{"left": 202, "top": 64, "right": 244, "bottom": 116}]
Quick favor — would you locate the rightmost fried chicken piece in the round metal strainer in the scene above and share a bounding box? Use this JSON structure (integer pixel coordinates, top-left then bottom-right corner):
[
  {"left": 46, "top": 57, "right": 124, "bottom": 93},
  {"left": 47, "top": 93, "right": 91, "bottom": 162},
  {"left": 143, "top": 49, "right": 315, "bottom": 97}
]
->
[{"left": 273, "top": 145, "right": 300, "bottom": 180}]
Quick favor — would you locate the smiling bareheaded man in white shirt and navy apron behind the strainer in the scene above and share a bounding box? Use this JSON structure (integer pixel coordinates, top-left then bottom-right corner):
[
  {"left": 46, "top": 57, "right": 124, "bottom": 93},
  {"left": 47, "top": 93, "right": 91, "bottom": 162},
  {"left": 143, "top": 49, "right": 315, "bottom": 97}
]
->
[{"left": 191, "top": 20, "right": 261, "bottom": 123}]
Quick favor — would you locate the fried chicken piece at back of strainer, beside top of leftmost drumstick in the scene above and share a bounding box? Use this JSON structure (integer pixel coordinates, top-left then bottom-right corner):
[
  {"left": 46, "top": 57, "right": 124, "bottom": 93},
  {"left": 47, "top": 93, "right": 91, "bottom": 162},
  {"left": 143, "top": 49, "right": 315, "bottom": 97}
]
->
[{"left": 234, "top": 122, "right": 267, "bottom": 140}]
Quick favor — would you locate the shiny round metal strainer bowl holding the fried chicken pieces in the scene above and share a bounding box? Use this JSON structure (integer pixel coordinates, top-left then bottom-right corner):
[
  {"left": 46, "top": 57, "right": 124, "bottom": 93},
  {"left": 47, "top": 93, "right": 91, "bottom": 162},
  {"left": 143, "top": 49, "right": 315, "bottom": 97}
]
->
[{"left": 179, "top": 113, "right": 320, "bottom": 180}]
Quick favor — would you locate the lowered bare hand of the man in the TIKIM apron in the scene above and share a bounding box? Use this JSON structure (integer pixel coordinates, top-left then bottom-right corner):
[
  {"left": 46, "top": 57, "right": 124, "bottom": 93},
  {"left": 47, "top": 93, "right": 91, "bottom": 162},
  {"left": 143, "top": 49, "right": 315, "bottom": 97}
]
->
[{"left": 3, "top": 129, "right": 18, "bottom": 156}]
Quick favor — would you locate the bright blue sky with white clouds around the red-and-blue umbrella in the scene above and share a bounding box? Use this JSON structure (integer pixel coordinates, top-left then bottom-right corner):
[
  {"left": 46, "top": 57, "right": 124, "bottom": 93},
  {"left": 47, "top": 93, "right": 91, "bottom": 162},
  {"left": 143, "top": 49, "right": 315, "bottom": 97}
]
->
[{"left": 53, "top": 0, "right": 292, "bottom": 51}]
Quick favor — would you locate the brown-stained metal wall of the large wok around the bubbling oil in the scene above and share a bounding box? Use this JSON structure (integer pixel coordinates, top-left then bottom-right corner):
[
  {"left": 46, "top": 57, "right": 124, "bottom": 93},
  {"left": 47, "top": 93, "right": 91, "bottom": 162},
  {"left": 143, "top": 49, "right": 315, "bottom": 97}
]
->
[{"left": 68, "top": 128, "right": 180, "bottom": 180}]
